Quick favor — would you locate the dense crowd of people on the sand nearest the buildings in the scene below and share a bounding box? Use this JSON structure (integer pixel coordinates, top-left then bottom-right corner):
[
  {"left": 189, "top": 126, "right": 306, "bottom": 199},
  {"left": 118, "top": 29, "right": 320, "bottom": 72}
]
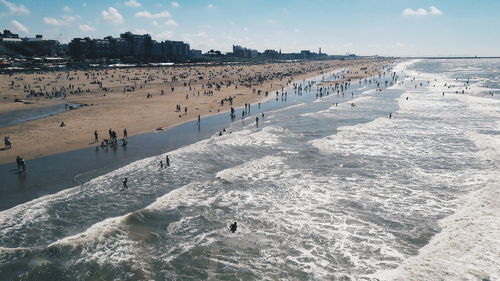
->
[{"left": 4, "top": 62, "right": 344, "bottom": 105}]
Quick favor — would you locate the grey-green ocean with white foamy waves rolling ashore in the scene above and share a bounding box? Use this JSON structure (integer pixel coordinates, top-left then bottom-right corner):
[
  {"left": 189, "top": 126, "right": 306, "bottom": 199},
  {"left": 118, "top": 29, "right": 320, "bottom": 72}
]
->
[{"left": 0, "top": 59, "right": 500, "bottom": 281}]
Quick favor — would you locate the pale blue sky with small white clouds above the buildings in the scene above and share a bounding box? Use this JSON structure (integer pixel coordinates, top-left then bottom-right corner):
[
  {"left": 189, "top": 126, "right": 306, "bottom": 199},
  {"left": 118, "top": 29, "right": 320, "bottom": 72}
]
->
[{"left": 0, "top": 0, "right": 500, "bottom": 56}]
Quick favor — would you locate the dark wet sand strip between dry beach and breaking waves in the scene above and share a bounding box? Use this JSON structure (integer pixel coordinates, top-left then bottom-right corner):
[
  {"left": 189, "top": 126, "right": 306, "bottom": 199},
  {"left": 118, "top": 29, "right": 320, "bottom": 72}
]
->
[{"left": 0, "top": 60, "right": 398, "bottom": 210}]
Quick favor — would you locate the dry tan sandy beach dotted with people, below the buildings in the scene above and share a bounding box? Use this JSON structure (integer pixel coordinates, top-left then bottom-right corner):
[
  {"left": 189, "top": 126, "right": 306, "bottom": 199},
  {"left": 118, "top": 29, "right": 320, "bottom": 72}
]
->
[{"left": 0, "top": 59, "right": 391, "bottom": 164}]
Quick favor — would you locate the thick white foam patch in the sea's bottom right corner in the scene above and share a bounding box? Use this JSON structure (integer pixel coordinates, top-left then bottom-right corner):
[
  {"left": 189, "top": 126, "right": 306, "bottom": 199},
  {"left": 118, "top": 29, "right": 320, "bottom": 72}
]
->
[{"left": 373, "top": 174, "right": 500, "bottom": 280}]
